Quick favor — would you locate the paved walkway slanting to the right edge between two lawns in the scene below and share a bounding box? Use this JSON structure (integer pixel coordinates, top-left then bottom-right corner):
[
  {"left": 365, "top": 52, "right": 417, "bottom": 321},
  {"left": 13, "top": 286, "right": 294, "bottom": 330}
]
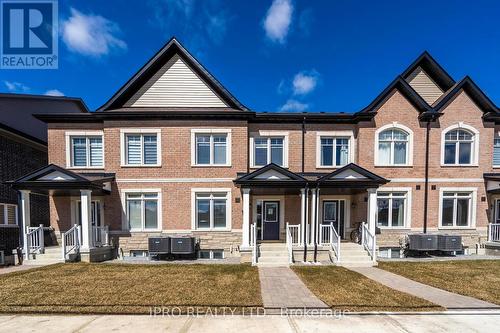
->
[{"left": 349, "top": 267, "right": 500, "bottom": 310}]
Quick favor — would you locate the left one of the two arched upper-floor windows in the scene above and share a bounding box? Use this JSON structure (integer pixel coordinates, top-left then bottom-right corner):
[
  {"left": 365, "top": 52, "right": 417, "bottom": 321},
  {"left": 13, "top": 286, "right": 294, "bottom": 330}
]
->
[{"left": 378, "top": 128, "right": 409, "bottom": 165}]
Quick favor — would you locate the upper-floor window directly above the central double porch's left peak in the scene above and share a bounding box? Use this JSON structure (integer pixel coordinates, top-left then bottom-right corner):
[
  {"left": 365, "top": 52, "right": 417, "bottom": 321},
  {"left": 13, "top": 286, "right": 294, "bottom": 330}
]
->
[{"left": 253, "top": 137, "right": 284, "bottom": 166}]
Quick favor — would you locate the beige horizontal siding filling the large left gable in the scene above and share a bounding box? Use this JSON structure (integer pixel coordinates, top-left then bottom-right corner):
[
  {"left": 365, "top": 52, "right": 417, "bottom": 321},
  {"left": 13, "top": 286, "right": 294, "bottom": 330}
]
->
[{"left": 125, "top": 55, "right": 227, "bottom": 107}]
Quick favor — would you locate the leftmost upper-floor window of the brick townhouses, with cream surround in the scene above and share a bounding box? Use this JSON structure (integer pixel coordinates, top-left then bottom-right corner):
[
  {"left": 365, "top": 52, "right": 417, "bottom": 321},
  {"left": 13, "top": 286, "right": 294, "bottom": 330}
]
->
[{"left": 66, "top": 132, "right": 104, "bottom": 168}]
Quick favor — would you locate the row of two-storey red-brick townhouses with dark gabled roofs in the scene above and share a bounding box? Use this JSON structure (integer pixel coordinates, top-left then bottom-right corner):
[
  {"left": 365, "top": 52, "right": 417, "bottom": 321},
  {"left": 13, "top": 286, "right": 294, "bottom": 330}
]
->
[{"left": 9, "top": 39, "right": 500, "bottom": 261}]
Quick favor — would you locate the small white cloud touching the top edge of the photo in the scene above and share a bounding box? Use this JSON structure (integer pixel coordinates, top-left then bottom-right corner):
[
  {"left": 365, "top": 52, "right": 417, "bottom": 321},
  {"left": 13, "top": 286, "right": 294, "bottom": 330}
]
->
[{"left": 264, "top": 0, "right": 293, "bottom": 43}]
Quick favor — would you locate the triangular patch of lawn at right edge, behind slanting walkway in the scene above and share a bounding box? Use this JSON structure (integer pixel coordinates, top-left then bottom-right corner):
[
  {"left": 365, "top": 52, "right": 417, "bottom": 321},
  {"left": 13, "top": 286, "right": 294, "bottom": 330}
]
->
[{"left": 378, "top": 260, "right": 500, "bottom": 304}]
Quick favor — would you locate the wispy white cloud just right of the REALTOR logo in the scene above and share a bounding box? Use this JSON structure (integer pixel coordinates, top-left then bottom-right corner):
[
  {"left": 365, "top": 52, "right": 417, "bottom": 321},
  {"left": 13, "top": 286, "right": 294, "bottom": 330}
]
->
[{"left": 61, "top": 8, "right": 127, "bottom": 57}]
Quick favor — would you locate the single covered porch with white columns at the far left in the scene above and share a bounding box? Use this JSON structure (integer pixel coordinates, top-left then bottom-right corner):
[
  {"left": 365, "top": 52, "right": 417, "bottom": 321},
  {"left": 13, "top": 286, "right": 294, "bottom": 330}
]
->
[{"left": 11, "top": 164, "right": 114, "bottom": 262}]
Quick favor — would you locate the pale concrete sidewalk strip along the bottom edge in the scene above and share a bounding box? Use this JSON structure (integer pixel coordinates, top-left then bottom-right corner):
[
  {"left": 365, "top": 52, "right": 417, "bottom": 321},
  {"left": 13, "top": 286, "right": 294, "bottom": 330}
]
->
[{"left": 0, "top": 314, "right": 500, "bottom": 333}]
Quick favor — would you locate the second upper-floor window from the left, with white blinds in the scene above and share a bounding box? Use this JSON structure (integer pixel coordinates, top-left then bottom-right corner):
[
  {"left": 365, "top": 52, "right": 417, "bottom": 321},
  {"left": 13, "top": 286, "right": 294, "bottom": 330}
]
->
[{"left": 125, "top": 133, "right": 159, "bottom": 166}]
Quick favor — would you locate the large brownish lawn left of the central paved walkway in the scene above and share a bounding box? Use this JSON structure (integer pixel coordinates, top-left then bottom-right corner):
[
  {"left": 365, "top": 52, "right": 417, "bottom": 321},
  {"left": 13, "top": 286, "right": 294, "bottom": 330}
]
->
[{"left": 0, "top": 263, "right": 262, "bottom": 314}]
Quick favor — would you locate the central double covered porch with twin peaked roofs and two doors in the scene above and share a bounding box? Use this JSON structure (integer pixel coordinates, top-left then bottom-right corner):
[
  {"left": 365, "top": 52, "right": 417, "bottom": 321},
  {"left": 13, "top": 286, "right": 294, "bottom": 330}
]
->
[{"left": 235, "top": 164, "right": 388, "bottom": 263}]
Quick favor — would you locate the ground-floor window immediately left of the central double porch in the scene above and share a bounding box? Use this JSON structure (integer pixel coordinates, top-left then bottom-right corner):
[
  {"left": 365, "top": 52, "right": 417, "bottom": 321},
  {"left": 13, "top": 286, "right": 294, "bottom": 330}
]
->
[{"left": 195, "top": 192, "right": 229, "bottom": 229}]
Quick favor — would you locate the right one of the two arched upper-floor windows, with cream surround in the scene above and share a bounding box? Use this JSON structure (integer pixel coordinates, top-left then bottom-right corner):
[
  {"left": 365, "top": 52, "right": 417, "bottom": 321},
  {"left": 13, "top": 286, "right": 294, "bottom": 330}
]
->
[{"left": 441, "top": 124, "right": 479, "bottom": 165}]
